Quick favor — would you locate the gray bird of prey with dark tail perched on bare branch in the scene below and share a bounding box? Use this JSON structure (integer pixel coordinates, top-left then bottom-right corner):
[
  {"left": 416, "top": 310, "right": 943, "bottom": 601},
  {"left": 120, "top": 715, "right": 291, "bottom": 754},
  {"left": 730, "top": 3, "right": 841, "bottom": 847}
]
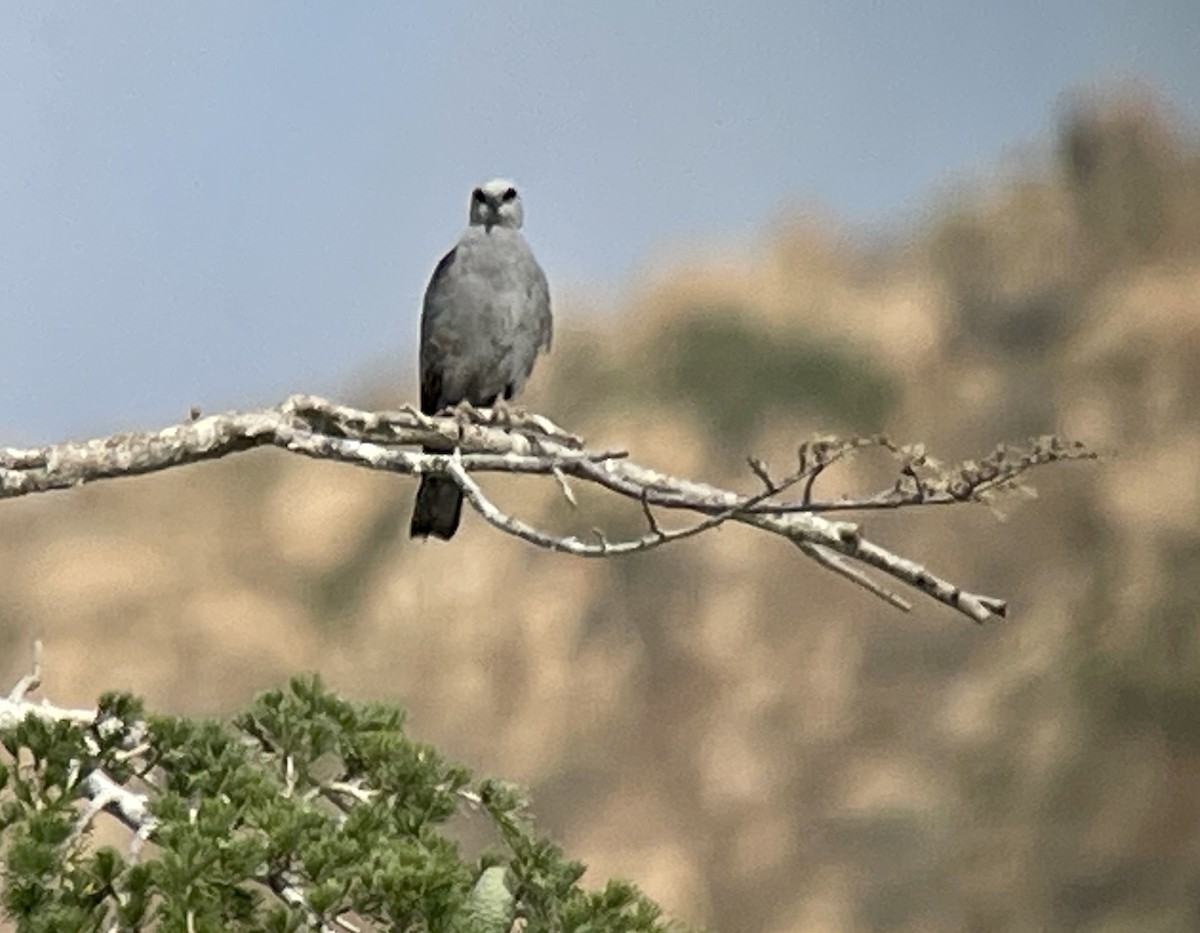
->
[{"left": 409, "top": 179, "right": 552, "bottom": 540}]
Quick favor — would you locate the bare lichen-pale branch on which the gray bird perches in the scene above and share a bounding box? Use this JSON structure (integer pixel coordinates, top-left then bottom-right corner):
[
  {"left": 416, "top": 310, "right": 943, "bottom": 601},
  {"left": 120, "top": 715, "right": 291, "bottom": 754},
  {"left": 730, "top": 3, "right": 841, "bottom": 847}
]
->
[{"left": 0, "top": 395, "right": 1093, "bottom": 622}]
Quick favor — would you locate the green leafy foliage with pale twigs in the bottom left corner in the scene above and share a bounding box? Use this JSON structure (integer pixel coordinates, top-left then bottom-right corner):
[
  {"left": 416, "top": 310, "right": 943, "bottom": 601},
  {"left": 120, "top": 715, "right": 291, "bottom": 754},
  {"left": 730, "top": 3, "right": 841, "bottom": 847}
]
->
[{"left": 0, "top": 678, "right": 686, "bottom": 933}]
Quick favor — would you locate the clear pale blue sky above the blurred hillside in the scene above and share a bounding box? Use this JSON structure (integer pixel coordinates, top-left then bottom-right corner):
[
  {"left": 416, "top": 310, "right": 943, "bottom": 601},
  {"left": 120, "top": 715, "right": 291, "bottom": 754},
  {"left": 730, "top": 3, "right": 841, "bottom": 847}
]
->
[{"left": 0, "top": 0, "right": 1200, "bottom": 444}]
